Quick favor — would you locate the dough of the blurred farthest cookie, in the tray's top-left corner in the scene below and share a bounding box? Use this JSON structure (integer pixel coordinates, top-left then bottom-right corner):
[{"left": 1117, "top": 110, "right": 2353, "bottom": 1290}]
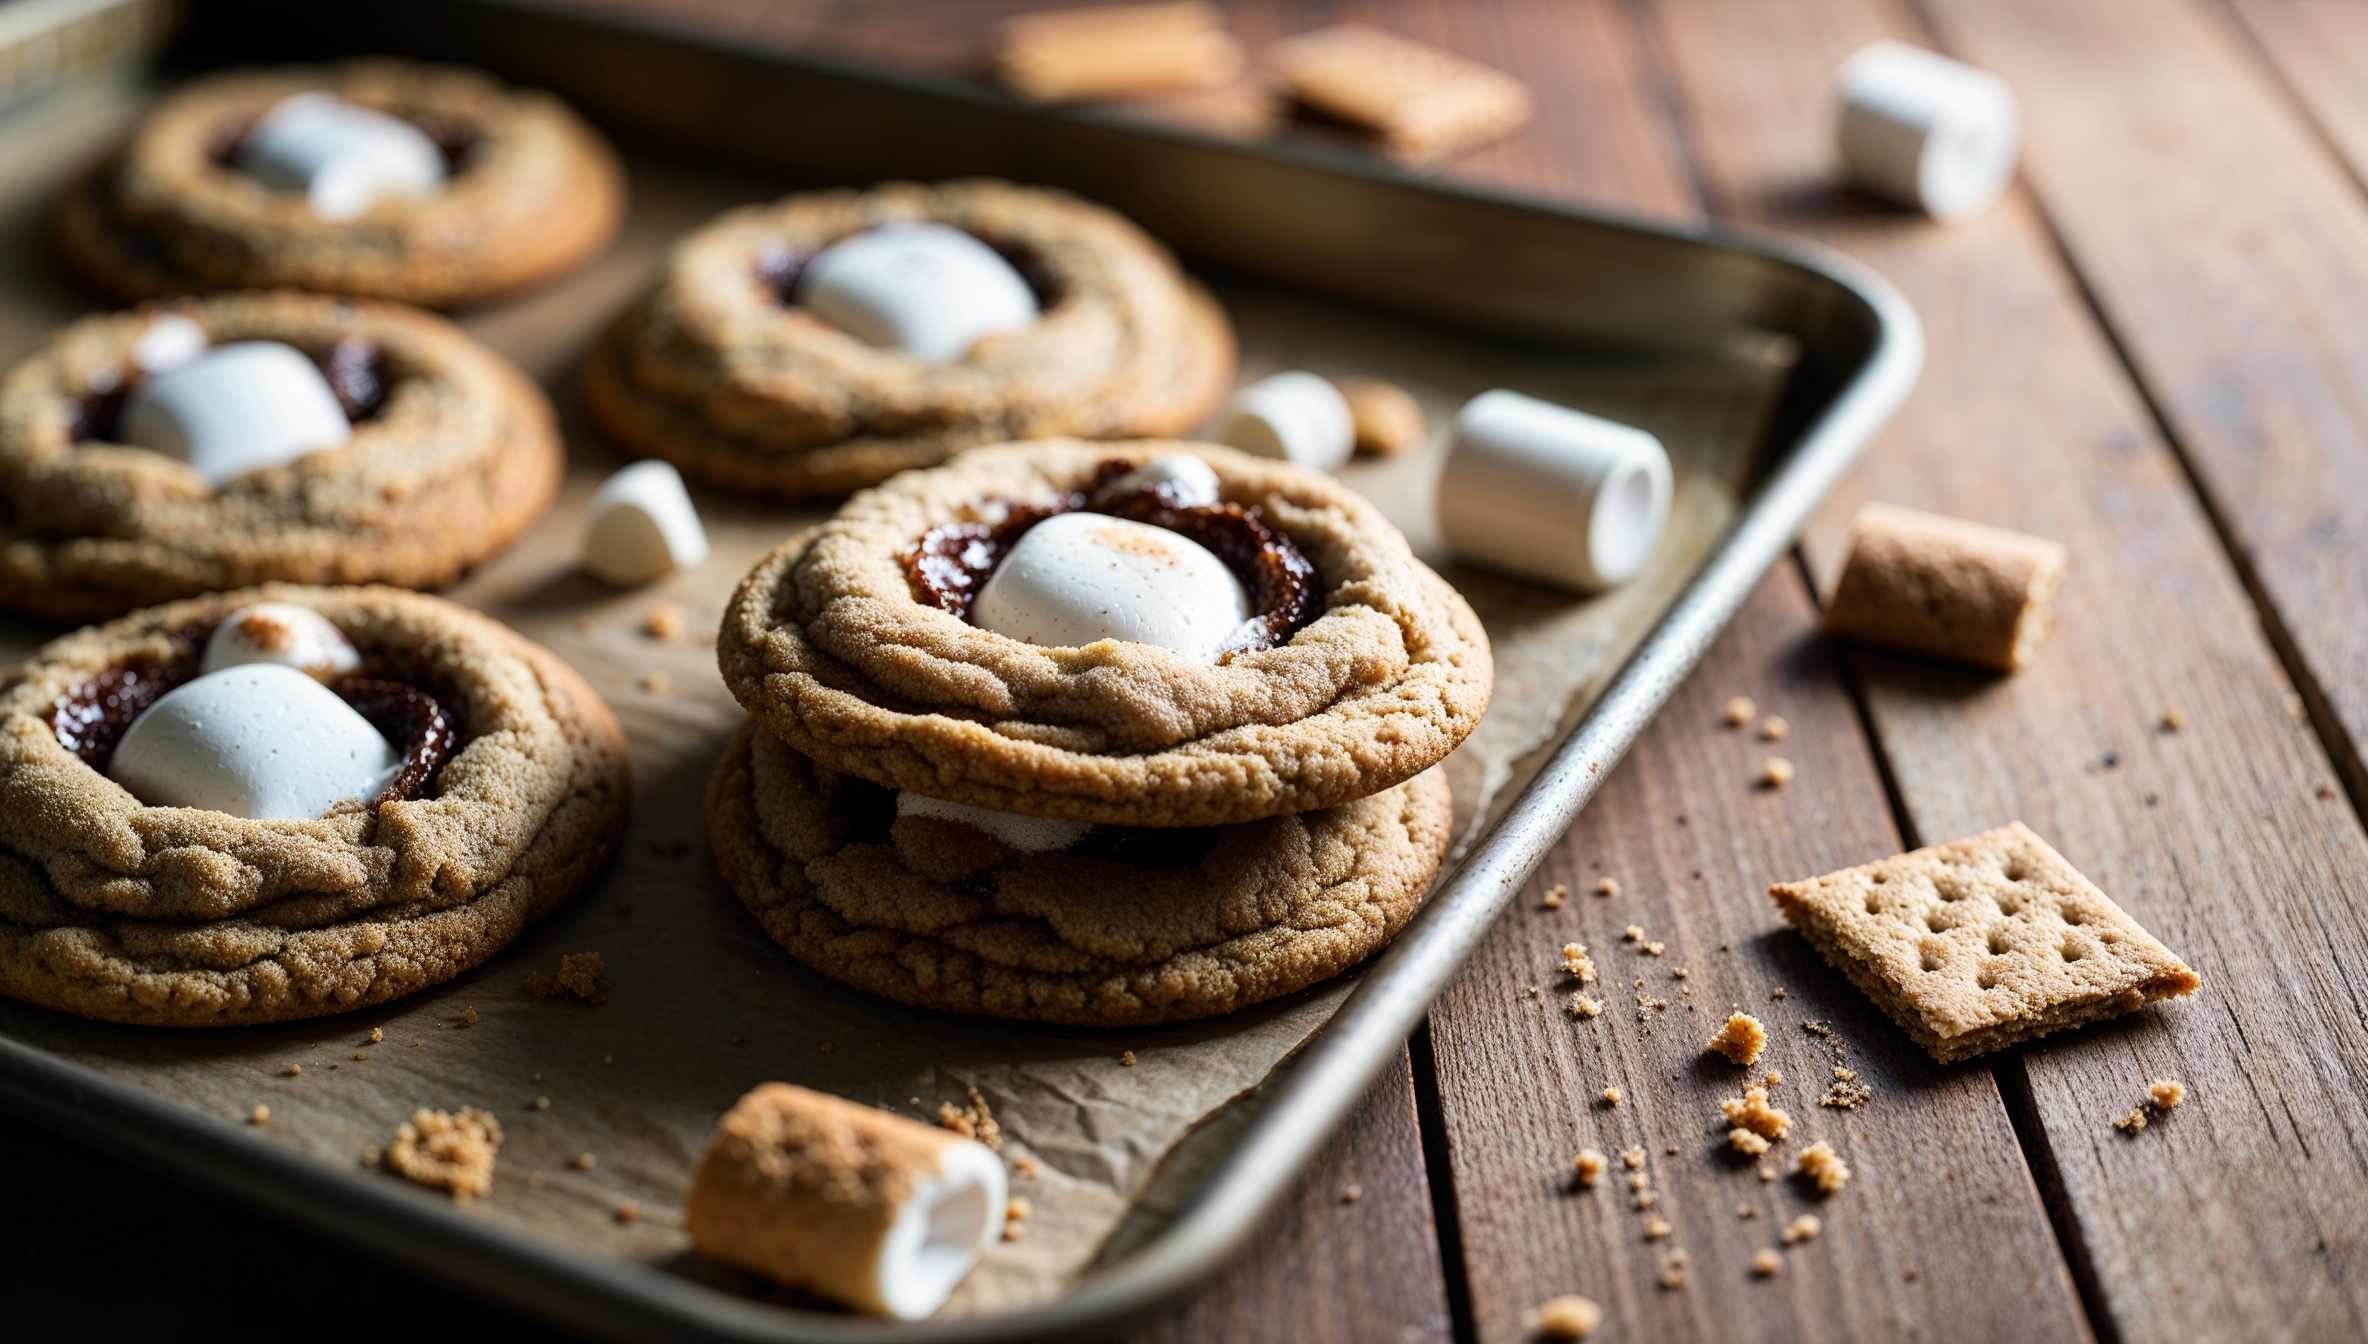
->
[{"left": 57, "top": 59, "right": 625, "bottom": 308}]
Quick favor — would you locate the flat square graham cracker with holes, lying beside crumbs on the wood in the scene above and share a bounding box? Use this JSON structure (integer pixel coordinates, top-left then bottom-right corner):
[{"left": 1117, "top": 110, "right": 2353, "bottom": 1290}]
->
[{"left": 1769, "top": 821, "right": 2202, "bottom": 1065}]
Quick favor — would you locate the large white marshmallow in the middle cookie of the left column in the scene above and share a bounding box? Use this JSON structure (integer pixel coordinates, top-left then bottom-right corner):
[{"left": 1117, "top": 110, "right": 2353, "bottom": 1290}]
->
[{"left": 116, "top": 341, "right": 353, "bottom": 485}]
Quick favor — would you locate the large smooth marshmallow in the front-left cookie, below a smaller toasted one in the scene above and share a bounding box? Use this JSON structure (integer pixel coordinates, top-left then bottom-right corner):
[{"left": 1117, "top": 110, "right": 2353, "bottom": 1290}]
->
[{"left": 107, "top": 663, "right": 403, "bottom": 821}]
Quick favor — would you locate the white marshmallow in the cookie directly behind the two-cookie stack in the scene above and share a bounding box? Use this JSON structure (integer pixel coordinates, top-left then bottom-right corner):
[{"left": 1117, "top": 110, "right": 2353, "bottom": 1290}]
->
[{"left": 798, "top": 222, "right": 1037, "bottom": 364}]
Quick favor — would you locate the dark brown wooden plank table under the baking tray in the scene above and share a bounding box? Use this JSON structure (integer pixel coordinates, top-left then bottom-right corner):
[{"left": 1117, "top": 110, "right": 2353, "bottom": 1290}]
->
[{"left": 18, "top": 0, "right": 2368, "bottom": 1344}]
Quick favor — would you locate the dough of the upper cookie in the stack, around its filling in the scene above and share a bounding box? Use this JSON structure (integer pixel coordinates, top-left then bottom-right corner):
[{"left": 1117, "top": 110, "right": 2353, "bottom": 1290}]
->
[{"left": 715, "top": 440, "right": 1494, "bottom": 826}]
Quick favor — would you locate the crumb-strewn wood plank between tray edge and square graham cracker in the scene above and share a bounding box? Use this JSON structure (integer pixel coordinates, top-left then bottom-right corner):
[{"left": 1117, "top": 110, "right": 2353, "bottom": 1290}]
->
[{"left": 1430, "top": 566, "right": 2086, "bottom": 1342}]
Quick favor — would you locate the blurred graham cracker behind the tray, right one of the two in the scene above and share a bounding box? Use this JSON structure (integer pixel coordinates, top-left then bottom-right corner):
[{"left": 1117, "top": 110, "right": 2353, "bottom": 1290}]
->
[{"left": 1267, "top": 24, "right": 1530, "bottom": 163}]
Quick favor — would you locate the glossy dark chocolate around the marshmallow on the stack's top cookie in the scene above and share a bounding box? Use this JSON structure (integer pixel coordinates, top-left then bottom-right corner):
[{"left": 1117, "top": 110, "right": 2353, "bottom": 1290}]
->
[{"left": 900, "top": 459, "right": 1317, "bottom": 658}]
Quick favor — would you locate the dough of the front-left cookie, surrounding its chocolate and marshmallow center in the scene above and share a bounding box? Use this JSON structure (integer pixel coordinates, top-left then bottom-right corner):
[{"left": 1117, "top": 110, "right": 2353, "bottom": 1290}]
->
[{"left": 0, "top": 584, "right": 630, "bottom": 1027}]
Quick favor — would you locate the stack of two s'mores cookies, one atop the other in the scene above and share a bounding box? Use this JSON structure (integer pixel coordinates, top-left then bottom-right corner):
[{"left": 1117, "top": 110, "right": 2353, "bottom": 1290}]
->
[{"left": 708, "top": 440, "right": 1492, "bottom": 1027}]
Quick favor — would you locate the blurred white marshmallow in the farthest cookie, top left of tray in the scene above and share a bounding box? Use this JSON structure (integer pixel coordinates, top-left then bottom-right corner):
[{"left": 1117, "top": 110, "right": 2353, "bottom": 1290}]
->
[{"left": 237, "top": 90, "right": 445, "bottom": 220}]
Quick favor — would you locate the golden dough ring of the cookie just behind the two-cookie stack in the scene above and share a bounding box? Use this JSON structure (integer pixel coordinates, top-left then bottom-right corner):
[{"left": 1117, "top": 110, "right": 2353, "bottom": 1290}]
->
[{"left": 583, "top": 180, "right": 1234, "bottom": 499}]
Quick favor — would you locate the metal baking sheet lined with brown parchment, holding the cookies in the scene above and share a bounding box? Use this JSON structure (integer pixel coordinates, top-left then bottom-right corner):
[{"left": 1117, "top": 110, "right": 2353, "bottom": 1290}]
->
[{"left": 0, "top": 2, "right": 1920, "bottom": 1339}]
